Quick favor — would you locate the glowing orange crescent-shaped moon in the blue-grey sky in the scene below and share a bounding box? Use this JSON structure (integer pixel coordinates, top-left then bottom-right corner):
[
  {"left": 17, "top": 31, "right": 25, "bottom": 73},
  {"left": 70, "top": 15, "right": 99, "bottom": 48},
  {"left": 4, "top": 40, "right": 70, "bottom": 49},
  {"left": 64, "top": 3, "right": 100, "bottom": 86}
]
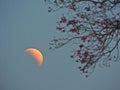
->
[{"left": 25, "top": 48, "right": 43, "bottom": 65}]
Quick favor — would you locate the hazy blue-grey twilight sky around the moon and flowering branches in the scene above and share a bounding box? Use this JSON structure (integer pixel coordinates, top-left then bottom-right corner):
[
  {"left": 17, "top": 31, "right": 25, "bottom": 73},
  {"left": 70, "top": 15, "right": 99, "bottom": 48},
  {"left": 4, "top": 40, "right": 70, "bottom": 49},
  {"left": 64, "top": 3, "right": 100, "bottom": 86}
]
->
[{"left": 0, "top": 0, "right": 120, "bottom": 90}]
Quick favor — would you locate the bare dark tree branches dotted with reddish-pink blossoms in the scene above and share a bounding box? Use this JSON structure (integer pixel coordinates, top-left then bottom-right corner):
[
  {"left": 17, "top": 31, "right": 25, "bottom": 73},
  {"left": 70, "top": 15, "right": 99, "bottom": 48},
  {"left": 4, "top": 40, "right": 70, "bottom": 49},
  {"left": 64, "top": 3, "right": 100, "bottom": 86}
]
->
[{"left": 45, "top": 0, "right": 120, "bottom": 77}]
